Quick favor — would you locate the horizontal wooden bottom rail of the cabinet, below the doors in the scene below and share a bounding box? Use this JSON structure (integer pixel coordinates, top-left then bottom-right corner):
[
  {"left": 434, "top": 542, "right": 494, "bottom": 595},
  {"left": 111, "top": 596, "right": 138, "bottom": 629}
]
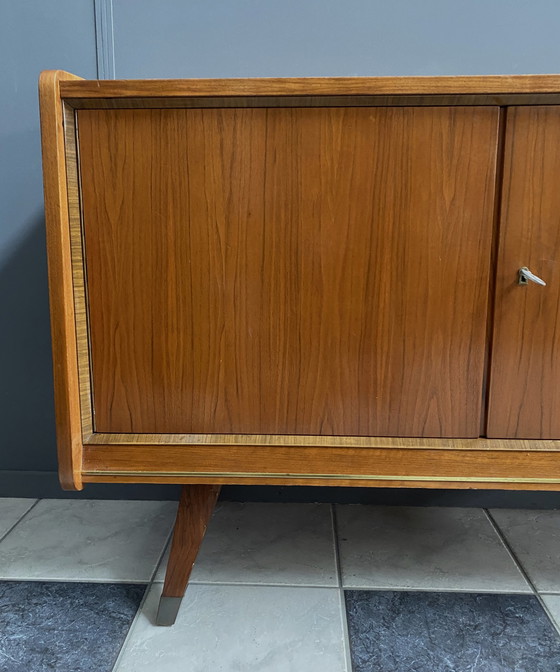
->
[{"left": 80, "top": 444, "right": 560, "bottom": 489}]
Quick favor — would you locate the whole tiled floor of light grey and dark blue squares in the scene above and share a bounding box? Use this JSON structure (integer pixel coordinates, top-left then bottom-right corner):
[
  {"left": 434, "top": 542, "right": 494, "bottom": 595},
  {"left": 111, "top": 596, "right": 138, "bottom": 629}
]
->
[{"left": 0, "top": 499, "right": 560, "bottom": 672}]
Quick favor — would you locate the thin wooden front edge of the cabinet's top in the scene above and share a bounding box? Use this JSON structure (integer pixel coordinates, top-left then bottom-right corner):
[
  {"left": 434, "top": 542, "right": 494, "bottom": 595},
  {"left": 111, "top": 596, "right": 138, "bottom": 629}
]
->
[{"left": 52, "top": 74, "right": 560, "bottom": 98}]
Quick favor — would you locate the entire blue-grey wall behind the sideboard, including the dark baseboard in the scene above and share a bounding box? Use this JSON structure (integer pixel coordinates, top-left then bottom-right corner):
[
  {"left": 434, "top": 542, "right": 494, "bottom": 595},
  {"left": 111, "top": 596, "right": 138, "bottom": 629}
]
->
[{"left": 0, "top": 0, "right": 560, "bottom": 506}]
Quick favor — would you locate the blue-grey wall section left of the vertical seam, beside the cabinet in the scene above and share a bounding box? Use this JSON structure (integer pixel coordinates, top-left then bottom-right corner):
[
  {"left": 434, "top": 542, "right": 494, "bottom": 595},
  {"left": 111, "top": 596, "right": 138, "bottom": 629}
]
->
[{"left": 0, "top": 0, "right": 96, "bottom": 476}]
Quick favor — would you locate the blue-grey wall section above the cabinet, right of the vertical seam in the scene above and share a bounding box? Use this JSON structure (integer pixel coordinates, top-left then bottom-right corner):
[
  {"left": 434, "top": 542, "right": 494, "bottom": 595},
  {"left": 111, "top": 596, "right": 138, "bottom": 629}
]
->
[{"left": 110, "top": 0, "right": 560, "bottom": 78}]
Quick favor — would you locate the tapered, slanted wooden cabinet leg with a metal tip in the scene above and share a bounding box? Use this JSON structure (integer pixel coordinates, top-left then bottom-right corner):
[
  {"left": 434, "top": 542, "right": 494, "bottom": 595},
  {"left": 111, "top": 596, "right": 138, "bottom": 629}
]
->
[{"left": 156, "top": 485, "right": 221, "bottom": 625}]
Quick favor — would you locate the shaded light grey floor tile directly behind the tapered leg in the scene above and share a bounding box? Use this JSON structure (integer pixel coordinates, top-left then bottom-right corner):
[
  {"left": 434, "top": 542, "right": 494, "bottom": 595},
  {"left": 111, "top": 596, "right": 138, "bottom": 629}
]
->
[{"left": 156, "top": 502, "right": 337, "bottom": 586}]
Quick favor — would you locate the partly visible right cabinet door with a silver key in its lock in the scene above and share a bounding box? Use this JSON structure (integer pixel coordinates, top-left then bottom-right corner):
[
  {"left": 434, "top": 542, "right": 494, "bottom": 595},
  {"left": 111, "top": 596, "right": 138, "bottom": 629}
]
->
[{"left": 488, "top": 107, "right": 560, "bottom": 439}]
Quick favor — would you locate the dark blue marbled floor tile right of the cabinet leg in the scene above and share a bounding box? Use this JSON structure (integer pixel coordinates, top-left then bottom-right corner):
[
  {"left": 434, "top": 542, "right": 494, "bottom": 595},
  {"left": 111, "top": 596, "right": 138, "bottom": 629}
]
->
[{"left": 346, "top": 591, "right": 560, "bottom": 672}]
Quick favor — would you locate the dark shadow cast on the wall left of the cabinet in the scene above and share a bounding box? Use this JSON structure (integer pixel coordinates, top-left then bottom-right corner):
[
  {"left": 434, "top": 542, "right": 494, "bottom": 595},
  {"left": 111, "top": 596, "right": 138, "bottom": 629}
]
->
[{"left": 0, "top": 218, "right": 56, "bottom": 471}]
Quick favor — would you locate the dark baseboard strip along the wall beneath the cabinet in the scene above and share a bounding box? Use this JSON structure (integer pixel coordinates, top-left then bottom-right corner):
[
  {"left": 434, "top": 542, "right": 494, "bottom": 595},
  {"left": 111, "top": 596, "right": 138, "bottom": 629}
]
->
[{"left": 0, "top": 470, "right": 560, "bottom": 509}]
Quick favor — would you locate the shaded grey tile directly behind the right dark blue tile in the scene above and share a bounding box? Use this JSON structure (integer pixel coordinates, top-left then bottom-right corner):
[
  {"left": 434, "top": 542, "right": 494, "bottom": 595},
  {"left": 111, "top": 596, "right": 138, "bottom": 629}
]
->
[{"left": 336, "top": 505, "right": 531, "bottom": 593}]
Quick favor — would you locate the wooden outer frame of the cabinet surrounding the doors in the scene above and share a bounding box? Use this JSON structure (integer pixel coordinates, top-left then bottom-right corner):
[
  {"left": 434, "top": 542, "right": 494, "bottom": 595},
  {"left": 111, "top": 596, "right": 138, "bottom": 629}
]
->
[{"left": 39, "top": 71, "right": 560, "bottom": 490}]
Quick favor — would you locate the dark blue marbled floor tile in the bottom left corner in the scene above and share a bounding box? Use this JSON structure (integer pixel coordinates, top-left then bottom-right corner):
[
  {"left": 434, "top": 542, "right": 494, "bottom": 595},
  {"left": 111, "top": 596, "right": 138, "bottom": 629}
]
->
[{"left": 0, "top": 581, "right": 145, "bottom": 672}]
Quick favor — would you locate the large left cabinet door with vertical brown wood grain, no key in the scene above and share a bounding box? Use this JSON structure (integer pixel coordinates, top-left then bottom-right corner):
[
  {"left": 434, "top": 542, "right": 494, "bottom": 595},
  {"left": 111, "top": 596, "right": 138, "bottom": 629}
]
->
[{"left": 78, "top": 107, "right": 498, "bottom": 437}]
